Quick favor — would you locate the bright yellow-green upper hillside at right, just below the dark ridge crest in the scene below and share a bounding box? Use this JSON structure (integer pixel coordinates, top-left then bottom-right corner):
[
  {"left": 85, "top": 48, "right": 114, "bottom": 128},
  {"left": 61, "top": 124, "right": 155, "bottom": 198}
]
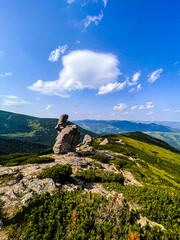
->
[{"left": 94, "top": 133, "right": 180, "bottom": 189}]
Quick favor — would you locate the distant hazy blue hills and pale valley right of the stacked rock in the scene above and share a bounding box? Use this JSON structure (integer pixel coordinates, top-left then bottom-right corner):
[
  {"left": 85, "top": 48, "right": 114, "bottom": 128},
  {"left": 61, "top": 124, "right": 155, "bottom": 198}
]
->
[{"left": 75, "top": 120, "right": 180, "bottom": 150}]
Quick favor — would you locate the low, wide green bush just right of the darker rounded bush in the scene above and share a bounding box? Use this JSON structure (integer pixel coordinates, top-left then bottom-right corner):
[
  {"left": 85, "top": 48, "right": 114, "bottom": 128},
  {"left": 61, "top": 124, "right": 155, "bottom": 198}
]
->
[{"left": 77, "top": 169, "right": 124, "bottom": 184}]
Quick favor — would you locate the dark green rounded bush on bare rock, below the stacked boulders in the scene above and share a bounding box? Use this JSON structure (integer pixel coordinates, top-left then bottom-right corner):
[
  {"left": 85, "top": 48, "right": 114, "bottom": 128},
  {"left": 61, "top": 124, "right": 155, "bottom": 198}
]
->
[{"left": 37, "top": 164, "right": 72, "bottom": 183}]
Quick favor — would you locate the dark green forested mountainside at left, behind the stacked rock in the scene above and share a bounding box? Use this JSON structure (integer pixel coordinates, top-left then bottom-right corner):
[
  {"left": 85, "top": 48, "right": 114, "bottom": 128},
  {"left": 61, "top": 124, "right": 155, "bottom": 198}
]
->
[{"left": 0, "top": 111, "right": 96, "bottom": 153}]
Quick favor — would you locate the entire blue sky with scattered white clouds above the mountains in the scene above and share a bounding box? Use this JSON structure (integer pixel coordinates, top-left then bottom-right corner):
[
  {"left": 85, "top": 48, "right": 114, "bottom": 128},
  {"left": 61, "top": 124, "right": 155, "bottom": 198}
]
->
[{"left": 0, "top": 0, "right": 180, "bottom": 121}]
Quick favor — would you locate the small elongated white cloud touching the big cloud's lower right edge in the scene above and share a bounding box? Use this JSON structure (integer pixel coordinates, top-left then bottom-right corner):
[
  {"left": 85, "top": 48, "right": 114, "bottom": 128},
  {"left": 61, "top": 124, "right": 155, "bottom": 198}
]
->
[{"left": 98, "top": 81, "right": 127, "bottom": 95}]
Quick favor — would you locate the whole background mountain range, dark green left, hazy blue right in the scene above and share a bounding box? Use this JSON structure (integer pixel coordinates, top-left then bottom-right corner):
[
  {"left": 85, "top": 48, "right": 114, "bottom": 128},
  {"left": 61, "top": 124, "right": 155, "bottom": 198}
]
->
[{"left": 0, "top": 111, "right": 180, "bottom": 154}]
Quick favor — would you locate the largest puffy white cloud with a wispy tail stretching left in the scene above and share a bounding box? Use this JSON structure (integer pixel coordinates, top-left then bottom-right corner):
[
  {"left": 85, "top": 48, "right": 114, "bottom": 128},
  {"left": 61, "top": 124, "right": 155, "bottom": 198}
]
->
[{"left": 28, "top": 50, "right": 121, "bottom": 97}]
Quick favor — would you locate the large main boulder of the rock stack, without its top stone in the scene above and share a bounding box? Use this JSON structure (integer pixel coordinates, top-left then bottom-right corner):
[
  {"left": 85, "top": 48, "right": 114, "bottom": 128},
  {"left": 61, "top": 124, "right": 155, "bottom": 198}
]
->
[{"left": 53, "top": 125, "right": 80, "bottom": 154}]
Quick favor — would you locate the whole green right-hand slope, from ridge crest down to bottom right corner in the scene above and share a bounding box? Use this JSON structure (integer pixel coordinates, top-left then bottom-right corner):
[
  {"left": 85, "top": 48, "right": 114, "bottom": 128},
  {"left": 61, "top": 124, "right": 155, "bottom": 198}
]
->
[{"left": 94, "top": 133, "right": 180, "bottom": 236}]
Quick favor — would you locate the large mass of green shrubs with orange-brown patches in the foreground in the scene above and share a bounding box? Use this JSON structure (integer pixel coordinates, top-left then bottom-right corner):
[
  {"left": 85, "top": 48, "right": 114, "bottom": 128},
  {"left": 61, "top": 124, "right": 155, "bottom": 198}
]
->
[{"left": 9, "top": 190, "right": 167, "bottom": 240}]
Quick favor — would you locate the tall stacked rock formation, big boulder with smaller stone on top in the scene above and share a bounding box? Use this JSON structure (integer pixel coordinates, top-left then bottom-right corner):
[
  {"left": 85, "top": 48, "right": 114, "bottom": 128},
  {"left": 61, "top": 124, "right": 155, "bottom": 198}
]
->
[{"left": 53, "top": 114, "right": 80, "bottom": 154}]
